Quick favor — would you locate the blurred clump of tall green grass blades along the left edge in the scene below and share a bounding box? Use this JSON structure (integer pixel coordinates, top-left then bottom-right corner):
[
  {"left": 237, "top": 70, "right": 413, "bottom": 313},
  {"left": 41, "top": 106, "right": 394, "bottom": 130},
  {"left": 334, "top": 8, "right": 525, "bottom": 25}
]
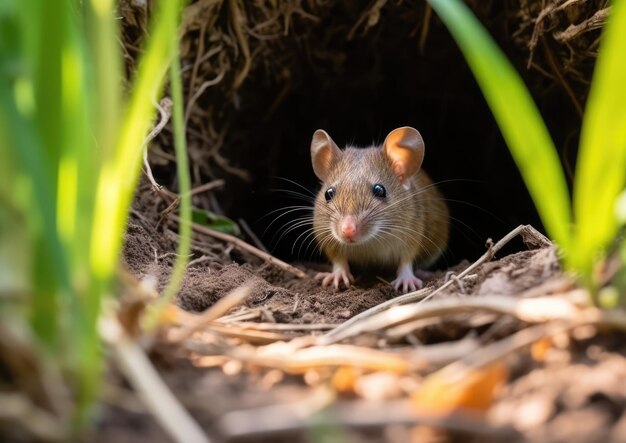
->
[{"left": 0, "top": 0, "right": 182, "bottom": 424}]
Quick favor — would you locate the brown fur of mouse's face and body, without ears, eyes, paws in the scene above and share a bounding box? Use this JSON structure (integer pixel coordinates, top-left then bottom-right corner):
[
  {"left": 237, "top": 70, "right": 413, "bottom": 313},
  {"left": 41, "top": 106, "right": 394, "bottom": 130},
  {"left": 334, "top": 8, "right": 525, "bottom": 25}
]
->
[{"left": 313, "top": 147, "right": 450, "bottom": 267}]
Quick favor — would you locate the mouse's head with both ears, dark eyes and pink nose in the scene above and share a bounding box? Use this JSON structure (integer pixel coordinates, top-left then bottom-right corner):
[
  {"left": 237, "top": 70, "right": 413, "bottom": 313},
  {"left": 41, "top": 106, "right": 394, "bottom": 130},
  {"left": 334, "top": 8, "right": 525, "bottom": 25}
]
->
[{"left": 311, "top": 126, "right": 424, "bottom": 244}]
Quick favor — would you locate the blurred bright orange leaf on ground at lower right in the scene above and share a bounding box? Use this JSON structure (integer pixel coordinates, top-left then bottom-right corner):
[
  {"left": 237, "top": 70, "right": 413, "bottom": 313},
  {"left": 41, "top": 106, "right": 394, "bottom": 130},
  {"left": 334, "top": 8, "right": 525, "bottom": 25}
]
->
[{"left": 411, "top": 362, "right": 509, "bottom": 415}]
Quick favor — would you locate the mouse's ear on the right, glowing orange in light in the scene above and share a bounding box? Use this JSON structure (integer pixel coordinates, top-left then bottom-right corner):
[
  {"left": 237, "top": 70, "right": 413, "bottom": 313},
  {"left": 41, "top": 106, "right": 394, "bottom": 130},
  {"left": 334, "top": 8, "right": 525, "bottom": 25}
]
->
[{"left": 383, "top": 126, "right": 424, "bottom": 189}]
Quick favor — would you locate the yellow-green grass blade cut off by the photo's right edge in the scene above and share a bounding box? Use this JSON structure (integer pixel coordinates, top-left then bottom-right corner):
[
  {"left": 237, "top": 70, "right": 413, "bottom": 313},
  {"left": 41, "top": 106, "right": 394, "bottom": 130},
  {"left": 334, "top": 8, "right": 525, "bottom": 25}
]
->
[{"left": 567, "top": 1, "right": 626, "bottom": 283}]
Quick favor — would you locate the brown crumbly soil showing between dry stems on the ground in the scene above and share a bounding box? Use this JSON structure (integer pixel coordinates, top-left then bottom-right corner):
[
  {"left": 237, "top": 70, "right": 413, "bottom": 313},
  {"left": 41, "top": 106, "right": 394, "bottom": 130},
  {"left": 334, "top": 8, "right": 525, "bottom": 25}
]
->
[{"left": 89, "top": 187, "right": 626, "bottom": 442}]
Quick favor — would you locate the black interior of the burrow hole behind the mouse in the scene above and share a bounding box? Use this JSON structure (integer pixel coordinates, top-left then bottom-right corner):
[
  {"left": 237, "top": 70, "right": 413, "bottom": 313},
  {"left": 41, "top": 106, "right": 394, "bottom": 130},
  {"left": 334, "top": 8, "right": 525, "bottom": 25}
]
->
[{"left": 188, "top": 2, "right": 579, "bottom": 266}]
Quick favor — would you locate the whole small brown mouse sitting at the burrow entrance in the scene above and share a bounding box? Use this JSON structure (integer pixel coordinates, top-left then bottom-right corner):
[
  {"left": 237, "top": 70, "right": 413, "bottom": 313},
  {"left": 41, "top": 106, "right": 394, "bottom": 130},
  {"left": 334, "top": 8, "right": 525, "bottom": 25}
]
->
[{"left": 311, "top": 126, "right": 450, "bottom": 292}]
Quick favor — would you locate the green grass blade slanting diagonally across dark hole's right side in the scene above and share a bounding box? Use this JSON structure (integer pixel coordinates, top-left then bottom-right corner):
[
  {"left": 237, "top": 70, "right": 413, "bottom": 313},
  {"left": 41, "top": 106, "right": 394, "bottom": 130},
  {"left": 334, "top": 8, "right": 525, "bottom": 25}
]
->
[{"left": 429, "top": 0, "right": 571, "bottom": 248}]
